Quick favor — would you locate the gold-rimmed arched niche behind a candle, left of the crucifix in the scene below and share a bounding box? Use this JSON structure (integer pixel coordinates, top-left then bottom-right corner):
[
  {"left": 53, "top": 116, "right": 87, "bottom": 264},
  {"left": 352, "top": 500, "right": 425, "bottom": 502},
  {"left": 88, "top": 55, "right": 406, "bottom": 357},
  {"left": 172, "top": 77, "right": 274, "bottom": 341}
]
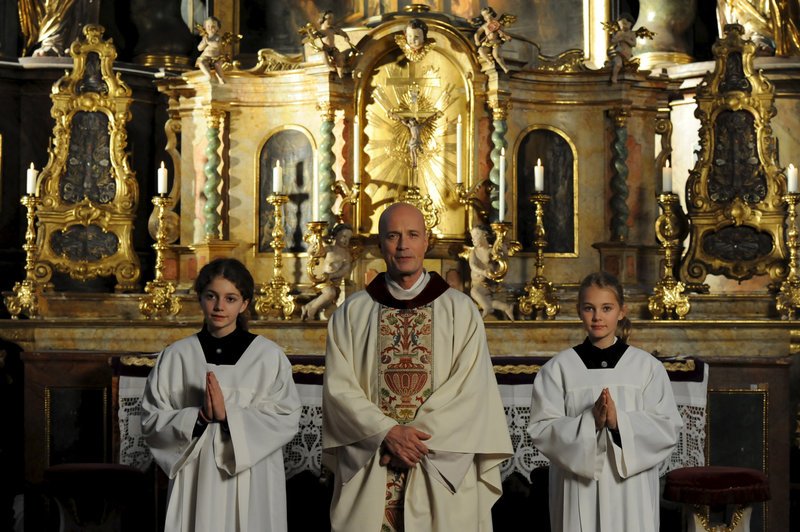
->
[{"left": 256, "top": 126, "right": 315, "bottom": 253}]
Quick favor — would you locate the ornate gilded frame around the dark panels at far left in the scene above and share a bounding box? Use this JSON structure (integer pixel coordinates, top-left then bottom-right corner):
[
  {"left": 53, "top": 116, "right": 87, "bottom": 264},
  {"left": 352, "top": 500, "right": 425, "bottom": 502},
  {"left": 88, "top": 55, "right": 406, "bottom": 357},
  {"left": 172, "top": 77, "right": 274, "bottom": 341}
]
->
[{"left": 34, "top": 24, "right": 141, "bottom": 291}]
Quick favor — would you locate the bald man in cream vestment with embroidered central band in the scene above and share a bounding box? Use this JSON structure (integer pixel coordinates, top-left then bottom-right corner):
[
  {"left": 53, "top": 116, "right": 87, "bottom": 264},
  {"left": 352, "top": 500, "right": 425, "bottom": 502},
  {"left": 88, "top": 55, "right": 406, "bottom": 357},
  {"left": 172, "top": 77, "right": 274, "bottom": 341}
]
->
[{"left": 322, "top": 203, "right": 512, "bottom": 532}]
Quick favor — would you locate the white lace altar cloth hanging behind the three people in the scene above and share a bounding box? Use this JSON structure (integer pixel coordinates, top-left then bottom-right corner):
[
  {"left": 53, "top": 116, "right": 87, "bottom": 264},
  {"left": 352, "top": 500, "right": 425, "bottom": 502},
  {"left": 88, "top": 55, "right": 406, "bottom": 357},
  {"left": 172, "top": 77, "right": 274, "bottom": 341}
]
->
[{"left": 119, "top": 364, "right": 708, "bottom": 479}]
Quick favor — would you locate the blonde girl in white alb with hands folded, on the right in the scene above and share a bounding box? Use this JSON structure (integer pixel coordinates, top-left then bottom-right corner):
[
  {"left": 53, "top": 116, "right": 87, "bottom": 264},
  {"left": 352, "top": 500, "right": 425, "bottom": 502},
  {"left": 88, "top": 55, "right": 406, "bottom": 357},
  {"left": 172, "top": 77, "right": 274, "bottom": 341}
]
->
[{"left": 528, "top": 272, "right": 682, "bottom": 532}]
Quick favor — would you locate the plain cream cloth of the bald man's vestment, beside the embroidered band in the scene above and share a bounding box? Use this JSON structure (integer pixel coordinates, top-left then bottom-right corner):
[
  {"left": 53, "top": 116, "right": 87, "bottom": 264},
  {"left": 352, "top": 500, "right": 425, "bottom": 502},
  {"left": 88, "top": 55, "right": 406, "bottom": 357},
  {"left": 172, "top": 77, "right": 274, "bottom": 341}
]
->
[{"left": 322, "top": 273, "right": 512, "bottom": 532}]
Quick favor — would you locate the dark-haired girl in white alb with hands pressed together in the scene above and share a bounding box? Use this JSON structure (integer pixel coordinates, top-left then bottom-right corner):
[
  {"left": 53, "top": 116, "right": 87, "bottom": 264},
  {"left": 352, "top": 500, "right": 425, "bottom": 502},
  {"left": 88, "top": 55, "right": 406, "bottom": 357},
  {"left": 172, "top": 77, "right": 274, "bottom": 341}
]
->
[{"left": 142, "top": 259, "right": 301, "bottom": 532}]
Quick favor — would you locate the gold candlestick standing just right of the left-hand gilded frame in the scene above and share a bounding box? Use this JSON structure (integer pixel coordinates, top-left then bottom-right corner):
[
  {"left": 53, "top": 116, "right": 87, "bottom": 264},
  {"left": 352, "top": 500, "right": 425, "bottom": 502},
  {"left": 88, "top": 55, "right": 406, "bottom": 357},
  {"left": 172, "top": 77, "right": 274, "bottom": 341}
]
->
[{"left": 139, "top": 194, "right": 181, "bottom": 319}]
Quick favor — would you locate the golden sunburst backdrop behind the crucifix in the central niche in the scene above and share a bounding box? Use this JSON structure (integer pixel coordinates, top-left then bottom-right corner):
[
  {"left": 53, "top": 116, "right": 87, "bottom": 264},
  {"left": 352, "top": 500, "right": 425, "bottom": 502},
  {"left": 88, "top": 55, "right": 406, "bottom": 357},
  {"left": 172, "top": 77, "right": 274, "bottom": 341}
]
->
[{"left": 364, "top": 74, "right": 462, "bottom": 214}]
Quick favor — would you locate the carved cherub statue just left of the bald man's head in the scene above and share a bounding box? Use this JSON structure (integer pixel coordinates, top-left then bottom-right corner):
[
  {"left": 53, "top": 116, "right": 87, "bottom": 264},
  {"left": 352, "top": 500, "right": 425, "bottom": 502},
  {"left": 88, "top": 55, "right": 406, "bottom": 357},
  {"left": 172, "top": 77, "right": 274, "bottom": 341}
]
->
[{"left": 300, "top": 224, "right": 353, "bottom": 320}]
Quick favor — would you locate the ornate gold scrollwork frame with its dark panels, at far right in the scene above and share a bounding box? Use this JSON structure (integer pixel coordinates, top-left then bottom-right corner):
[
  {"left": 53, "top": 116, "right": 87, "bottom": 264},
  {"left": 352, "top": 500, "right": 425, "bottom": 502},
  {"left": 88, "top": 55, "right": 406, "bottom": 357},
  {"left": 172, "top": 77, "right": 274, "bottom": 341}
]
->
[{"left": 680, "top": 24, "right": 786, "bottom": 286}]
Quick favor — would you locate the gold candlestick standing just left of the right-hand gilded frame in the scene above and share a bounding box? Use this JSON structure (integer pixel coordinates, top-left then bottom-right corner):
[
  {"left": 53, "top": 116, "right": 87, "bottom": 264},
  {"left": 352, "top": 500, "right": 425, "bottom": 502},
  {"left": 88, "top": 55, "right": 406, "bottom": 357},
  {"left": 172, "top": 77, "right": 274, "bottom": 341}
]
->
[{"left": 647, "top": 192, "right": 692, "bottom": 320}]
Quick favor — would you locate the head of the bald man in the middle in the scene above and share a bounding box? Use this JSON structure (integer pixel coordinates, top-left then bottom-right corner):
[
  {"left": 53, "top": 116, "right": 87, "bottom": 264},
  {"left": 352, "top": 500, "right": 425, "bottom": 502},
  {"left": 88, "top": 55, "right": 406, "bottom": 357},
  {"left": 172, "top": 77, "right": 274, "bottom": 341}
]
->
[{"left": 378, "top": 203, "right": 428, "bottom": 288}]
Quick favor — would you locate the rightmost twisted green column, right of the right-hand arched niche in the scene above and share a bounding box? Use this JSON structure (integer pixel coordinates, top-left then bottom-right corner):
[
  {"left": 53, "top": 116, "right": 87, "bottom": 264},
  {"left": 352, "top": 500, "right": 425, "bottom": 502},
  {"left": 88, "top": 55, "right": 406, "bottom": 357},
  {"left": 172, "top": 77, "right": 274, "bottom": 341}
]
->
[{"left": 610, "top": 109, "right": 630, "bottom": 242}]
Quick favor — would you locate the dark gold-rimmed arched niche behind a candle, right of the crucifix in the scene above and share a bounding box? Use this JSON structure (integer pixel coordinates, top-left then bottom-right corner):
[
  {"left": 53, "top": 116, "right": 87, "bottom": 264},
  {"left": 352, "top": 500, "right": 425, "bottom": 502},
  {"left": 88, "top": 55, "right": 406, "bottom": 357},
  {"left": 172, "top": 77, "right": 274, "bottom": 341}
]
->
[{"left": 516, "top": 126, "right": 578, "bottom": 257}]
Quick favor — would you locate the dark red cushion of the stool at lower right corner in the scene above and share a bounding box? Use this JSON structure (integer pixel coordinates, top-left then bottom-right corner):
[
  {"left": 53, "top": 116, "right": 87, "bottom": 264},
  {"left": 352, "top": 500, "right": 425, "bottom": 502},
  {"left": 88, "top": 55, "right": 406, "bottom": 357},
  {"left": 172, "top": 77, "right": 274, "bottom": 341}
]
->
[{"left": 664, "top": 466, "right": 770, "bottom": 506}]
